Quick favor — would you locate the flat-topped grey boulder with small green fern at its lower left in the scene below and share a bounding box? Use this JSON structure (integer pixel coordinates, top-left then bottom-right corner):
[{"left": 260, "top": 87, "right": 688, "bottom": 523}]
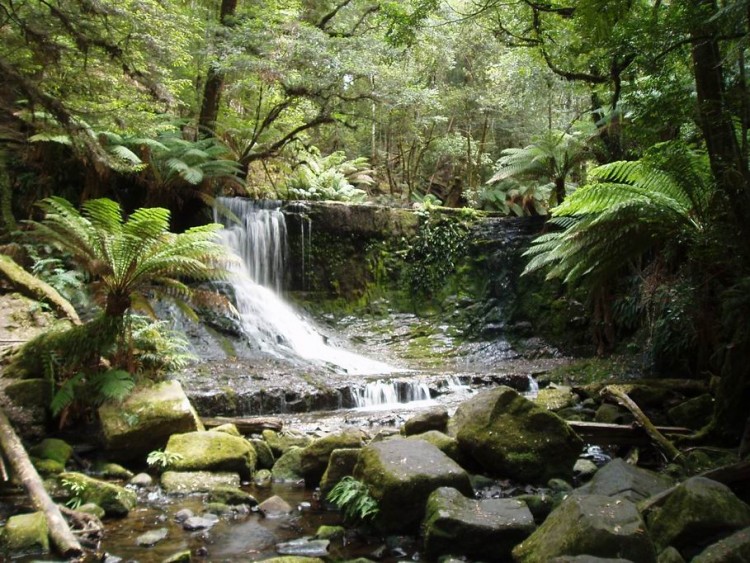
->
[{"left": 354, "top": 438, "right": 472, "bottom": 532}]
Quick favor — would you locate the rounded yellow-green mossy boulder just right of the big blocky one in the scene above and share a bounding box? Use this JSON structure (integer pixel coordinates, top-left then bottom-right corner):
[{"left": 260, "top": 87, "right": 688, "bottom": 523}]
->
[{"left": 164, "top": 430, "right": 256, "bottom": 480}]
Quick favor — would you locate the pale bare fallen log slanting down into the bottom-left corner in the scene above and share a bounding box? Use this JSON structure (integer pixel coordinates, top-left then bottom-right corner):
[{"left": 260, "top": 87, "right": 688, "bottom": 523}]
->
[{"left": 0, "top": 409, "right": 83, "bottom": 557}]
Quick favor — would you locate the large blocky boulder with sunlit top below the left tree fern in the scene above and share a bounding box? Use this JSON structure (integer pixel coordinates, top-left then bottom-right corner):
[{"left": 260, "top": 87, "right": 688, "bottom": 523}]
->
[{"left": 99, "top": 381, "right": 203, "bottom": 460}]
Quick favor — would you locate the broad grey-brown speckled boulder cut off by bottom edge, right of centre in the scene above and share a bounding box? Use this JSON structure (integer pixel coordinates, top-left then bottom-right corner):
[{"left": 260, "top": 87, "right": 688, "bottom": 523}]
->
[{"left": 513, "top": 494, "right": 656, "bottom": 563}]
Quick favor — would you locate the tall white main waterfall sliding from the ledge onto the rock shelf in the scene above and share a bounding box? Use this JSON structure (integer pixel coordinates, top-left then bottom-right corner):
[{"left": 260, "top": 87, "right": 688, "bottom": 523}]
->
[{"left": 214, "top": 198, "right": 393, "bottom": 375}]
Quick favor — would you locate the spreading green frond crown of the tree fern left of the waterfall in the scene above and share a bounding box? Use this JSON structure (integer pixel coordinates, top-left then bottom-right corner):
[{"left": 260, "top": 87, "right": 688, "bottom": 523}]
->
[{"left": 30, "top": 197, "right": 229, "bottom": 317}]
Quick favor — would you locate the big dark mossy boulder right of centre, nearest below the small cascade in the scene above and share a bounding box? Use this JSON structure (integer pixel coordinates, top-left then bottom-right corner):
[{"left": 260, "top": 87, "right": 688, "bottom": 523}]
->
[{"left": 448, "top": 386, "right": 583, "bottom": 483}]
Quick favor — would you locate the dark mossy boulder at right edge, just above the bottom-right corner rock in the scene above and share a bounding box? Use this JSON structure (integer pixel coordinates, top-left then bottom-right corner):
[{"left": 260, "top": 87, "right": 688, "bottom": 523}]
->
[{"left": 646, "top": 477, "right": 750, "bottom": 559}]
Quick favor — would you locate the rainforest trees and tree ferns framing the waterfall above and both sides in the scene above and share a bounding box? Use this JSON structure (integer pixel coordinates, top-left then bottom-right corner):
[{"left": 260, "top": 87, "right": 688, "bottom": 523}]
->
[{"left": 0, "top": 0, "right": 750, "bottom": 450}]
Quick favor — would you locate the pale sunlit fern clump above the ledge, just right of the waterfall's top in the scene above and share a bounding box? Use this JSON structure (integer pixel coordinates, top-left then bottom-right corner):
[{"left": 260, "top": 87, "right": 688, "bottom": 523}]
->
[{"left": 286, "top": 147, "right": 375, "bottom": 202}]
